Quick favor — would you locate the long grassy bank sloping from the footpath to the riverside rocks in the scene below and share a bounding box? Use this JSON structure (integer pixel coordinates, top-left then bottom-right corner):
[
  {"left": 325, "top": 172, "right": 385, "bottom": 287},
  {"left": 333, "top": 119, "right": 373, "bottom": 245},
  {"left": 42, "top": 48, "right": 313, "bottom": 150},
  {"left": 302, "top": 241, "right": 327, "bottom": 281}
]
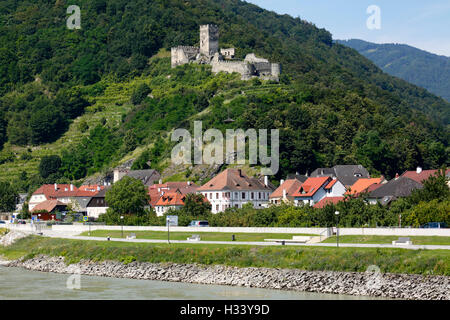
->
[{"left": 0, "top": 236, "right": 450, "bottom": 276}]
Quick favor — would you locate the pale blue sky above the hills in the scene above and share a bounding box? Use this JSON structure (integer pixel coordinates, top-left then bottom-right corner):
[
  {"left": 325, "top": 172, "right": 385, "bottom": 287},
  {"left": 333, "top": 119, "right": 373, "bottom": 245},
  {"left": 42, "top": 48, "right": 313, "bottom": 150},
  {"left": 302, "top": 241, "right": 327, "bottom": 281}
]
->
[{"left": 247, "top": 0, "right": 450, "bottom": 57}]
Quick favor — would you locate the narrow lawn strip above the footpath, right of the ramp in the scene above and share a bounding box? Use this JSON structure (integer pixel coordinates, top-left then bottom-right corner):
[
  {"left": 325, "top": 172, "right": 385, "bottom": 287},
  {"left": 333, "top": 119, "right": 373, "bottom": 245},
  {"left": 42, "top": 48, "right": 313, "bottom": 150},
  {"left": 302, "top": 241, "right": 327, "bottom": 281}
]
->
[{"left": 322, "top": 236, "right": 450, "bottom": 245}]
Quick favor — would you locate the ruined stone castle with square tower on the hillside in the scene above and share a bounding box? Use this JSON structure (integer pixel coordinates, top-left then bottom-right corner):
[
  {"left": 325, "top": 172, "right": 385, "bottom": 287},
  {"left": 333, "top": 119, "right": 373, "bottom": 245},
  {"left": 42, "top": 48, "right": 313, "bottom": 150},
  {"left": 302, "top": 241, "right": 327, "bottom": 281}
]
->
[{"left": 171, "top": 24, "right": 281, "bottom": 81}]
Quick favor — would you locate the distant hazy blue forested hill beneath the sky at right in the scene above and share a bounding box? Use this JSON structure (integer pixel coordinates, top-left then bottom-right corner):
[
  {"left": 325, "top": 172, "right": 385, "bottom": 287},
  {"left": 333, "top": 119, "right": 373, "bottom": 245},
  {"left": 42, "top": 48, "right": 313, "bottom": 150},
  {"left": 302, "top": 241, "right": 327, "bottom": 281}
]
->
[{"left": 338, "top": 39, "right": 450, "bottom": 101}]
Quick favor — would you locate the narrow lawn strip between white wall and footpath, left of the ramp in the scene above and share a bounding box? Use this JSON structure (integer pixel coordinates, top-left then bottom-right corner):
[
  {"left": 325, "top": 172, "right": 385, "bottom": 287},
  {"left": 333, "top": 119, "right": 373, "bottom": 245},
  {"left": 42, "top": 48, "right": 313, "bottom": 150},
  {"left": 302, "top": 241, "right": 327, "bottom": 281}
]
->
[{"left": 81, "top": 230, "right": 315, "bottom": 241}]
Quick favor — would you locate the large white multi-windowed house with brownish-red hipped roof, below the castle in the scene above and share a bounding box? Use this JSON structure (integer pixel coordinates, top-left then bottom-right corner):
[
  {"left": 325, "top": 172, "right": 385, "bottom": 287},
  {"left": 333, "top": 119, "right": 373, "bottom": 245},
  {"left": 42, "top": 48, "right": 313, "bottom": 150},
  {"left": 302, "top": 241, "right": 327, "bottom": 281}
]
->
[{"left": 197, "top": 169, "right": 273, "bottom": 213}]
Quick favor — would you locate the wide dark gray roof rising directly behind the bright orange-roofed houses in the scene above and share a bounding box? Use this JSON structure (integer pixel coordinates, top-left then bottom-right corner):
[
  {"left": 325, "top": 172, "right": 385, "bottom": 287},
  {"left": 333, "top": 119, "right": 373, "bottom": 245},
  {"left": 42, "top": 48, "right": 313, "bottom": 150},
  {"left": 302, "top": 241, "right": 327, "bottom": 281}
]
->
[{"left": 311, "top": 164, "right": 370, "bottom": 186}]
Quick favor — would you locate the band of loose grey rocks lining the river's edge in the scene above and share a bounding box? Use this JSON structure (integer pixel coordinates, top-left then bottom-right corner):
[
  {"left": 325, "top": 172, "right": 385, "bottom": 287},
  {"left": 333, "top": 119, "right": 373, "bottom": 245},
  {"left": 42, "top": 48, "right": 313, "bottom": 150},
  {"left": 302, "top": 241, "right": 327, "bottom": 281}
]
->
[{"left": 2, "top": 255, "right": 450, "bottom": 300}]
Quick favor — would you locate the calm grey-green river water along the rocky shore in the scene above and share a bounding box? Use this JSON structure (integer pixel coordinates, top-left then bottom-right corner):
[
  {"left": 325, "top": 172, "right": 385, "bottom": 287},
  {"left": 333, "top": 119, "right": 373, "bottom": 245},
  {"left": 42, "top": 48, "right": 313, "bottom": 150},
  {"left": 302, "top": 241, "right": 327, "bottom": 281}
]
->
[{"left": 0, "top": 266, "right": 384, "bottom": 300}]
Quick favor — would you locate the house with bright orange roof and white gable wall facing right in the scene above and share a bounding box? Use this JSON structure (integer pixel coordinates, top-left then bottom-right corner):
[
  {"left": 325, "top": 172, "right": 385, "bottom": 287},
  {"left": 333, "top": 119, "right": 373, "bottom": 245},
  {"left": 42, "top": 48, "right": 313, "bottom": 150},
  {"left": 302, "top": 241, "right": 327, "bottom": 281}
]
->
[{"left": 293, "top": 176, "right": 346, "bottom": 206}]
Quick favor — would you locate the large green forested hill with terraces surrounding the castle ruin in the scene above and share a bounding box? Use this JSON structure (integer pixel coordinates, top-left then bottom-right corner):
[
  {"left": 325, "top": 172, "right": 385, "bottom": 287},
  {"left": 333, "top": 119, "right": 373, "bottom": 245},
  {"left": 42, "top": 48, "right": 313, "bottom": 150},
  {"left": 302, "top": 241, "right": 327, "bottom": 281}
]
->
[{"left": 0, "top": 0, "right": 450, "bottom": 188}]
